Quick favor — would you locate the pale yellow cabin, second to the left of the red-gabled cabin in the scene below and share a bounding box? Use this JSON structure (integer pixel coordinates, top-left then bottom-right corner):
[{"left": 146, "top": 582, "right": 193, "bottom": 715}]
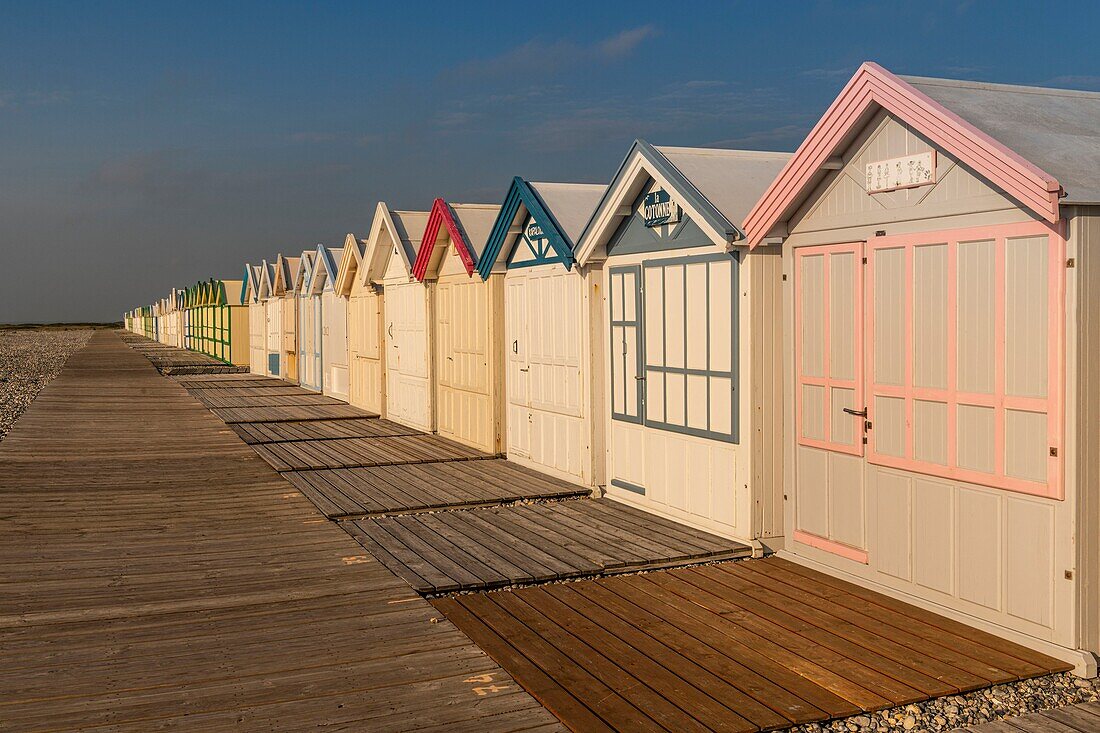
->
[{"left": 336, "top": 234, "right": 385, "bottom": 415}]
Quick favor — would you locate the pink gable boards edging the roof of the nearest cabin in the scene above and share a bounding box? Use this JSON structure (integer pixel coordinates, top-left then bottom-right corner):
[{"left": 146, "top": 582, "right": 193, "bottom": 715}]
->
[{"left": 744, "top": 62, "right": 1062, "bottom": 247}]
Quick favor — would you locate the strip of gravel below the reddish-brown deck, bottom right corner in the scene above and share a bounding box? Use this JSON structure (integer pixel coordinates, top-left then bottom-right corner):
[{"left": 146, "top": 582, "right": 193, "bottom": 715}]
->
[{"left": 790, "top": 674, "right": 1100, "bottom": 733}]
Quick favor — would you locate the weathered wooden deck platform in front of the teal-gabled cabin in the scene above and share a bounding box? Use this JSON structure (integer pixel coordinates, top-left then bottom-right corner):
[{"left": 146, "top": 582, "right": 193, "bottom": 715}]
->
[{"left": 283, "top": 458, "right": 591, "bottom": 519}]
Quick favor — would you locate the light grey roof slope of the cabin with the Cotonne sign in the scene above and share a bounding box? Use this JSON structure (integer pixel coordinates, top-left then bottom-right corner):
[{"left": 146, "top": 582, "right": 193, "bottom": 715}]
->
[{"left": 655, "top": 145, "right": 791, "bottom": 229}]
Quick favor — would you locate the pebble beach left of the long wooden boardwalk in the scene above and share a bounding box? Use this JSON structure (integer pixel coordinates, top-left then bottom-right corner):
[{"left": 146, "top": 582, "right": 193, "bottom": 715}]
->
[{"left": 0, "top": 328, "right": 92, "bottom": 440}]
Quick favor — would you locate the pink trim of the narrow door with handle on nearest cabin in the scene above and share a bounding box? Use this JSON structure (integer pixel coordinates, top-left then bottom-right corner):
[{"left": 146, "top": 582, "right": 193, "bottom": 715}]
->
[{"left": 794, "top": 242, "right": 864, "bottom": 456}]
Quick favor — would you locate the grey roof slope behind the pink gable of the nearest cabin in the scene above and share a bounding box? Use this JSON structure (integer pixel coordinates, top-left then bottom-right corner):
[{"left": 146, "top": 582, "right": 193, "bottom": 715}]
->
[{"left": 900, "top": 76, "right": 1100, "bottom": 204}]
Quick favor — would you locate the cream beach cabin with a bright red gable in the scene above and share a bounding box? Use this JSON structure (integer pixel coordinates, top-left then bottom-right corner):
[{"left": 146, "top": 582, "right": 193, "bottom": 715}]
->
[{"left": 413, "top": 198, "right": 505, "bottom": 453}]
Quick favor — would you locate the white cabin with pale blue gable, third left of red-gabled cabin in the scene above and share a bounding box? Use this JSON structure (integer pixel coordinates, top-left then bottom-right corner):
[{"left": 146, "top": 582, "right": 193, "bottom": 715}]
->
[{"left": 308, "top": 244, "right": 348, "bottom": 402}]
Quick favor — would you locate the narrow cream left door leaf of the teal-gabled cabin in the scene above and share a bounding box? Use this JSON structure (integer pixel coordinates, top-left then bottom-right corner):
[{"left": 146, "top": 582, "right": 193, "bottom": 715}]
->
[{"left": 504, "top": 273, "right": 531, "bottom": 458}]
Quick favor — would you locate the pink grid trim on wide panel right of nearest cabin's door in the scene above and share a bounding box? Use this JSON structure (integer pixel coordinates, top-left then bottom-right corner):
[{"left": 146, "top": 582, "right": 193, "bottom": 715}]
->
[{"left": 866, "top": 222, "right": 1065, "bottom": 500}]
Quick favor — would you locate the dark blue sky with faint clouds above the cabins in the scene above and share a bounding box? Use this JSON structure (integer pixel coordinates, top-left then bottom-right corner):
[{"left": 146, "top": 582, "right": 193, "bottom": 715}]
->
[{"left": 0, "top": 0, "right": 1100, "bottom": 322}]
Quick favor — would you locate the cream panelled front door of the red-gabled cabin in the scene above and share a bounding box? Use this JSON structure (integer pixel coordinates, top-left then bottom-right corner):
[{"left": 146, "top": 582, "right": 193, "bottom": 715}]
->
[{"left": 435, "top": 276, "right": 496, "bottom": 452}]
